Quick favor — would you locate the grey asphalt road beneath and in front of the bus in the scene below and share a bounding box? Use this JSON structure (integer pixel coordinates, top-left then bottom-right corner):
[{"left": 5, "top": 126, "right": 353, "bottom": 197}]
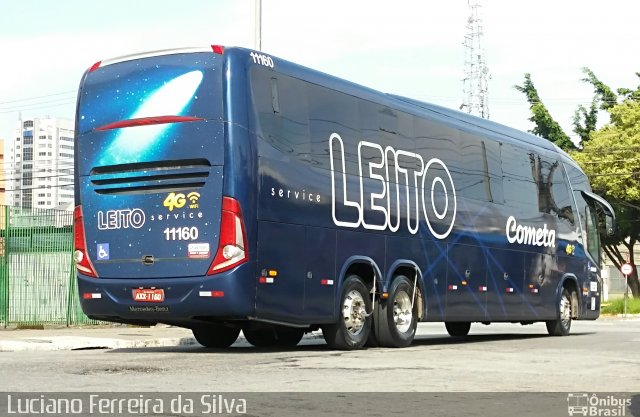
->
[{"left": 0, "top": 319, "right": 640, "bottom": 392}]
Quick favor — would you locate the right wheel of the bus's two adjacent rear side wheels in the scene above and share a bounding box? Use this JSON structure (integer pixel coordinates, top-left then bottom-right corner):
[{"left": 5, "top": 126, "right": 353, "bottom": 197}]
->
[{"left": 373, "top": 276, "right": 418, "bottom": 347}]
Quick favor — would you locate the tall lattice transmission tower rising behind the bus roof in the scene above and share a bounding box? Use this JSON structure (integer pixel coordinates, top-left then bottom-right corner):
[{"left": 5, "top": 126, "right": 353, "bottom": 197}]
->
[{"left": 460, "top": 0, "right": 491, "bottom": 119}]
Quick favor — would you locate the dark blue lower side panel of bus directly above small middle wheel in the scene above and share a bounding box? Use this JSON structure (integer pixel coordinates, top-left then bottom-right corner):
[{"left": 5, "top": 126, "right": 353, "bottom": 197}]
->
[{"left": 445, "top": 244, "right": 487, "bottom": 321}]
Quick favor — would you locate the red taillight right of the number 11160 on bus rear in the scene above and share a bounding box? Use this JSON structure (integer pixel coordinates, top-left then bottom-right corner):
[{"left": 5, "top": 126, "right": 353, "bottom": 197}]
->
[{"left": 207, "top": 197, "right": 249, "bottom": 275}]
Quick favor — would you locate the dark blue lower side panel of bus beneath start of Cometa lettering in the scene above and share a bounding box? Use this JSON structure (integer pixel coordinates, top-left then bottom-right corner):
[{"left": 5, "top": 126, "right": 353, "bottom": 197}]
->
[{"left": 487, "top": 249, "right": 527, "bottom": 320}]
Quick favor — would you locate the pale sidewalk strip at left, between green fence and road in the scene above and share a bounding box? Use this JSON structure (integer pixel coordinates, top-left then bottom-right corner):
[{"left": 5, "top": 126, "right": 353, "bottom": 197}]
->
[{"left": 0, "top": 325, "right": 198, "bottom": 352}]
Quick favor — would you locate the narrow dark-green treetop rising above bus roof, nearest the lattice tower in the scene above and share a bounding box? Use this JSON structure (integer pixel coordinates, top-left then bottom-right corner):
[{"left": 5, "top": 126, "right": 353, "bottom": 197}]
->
[{"left": 514, "top": 73, "right": 576, "bottom": 151}]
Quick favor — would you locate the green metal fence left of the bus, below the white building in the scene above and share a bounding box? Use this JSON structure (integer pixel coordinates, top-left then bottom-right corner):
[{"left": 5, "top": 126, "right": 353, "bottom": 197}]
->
[{"left": 0, "top": 206, "right": 97, "bottom": 327}]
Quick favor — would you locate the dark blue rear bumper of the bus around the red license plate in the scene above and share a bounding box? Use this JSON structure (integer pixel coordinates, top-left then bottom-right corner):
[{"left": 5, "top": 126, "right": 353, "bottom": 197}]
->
[{"left": 78, "top": 263, "right": 256, "bottom": 326}]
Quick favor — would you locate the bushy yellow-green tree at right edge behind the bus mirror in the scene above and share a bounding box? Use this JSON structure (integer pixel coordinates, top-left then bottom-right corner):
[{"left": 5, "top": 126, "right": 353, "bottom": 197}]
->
[{"left": 571, "top": 100, "right": 640, "bottom": 297}]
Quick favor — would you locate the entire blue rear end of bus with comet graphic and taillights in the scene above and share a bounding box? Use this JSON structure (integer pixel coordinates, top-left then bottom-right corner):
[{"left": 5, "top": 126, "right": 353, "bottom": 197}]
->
[{"left": 74, "top": 47, "right": 255, "bottom": 327}]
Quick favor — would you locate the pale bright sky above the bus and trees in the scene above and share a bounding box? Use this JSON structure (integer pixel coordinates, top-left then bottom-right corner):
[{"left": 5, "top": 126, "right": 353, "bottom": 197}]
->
[{"left": 0, "top": 0, "right": 640, "bottom": 145}]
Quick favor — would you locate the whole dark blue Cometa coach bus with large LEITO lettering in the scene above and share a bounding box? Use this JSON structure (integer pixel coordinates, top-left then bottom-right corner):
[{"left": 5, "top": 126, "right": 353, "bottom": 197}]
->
[{"left": 74, "top": 46, "right": 615, "bottom": 349}]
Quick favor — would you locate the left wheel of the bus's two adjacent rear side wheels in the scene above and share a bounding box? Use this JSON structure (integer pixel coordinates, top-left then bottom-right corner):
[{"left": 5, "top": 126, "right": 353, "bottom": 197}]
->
[{"left": 322, "top": 275, "right": 371, "bottom": 350}]
